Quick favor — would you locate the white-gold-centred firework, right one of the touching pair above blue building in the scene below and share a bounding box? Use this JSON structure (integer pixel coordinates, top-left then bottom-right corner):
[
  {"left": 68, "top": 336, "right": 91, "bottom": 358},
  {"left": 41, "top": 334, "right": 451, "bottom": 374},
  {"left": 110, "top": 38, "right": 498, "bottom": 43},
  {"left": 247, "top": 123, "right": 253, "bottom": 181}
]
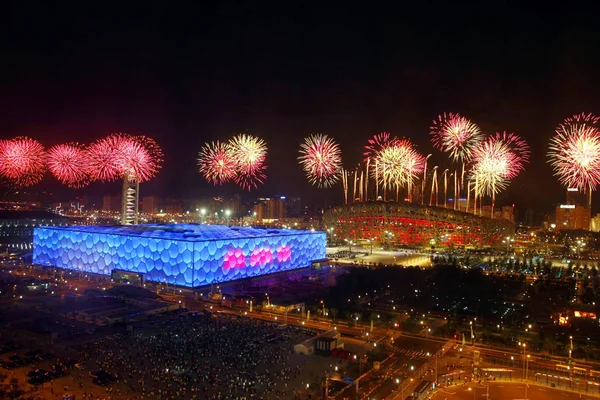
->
[{"left": 228, "top": 134, "right": 267, "bottom": 190}]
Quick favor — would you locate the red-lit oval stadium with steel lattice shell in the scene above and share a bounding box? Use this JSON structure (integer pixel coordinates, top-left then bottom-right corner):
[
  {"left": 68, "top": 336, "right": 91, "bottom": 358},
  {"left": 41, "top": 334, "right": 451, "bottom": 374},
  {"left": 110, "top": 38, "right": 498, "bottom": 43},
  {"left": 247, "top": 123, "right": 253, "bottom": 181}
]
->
[{"left": 323, "top": 202, "right": 515, "bottom": 246}]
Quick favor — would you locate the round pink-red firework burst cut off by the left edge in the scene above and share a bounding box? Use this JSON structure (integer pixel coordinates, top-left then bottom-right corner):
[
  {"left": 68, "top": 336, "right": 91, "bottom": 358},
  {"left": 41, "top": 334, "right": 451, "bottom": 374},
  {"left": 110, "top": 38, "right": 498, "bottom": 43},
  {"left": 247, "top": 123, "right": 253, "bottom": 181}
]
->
[{"left": 0, "top": 137, "right": 46, "bottom": 187}]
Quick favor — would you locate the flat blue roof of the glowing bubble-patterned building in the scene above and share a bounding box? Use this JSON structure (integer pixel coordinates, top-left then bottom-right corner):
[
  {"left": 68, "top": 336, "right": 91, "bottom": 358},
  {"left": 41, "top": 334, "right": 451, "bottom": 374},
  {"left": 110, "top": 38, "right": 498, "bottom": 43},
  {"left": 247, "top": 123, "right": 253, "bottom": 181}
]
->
[{"left": 35, "top": 224, "right": 322, "bottom": 242}]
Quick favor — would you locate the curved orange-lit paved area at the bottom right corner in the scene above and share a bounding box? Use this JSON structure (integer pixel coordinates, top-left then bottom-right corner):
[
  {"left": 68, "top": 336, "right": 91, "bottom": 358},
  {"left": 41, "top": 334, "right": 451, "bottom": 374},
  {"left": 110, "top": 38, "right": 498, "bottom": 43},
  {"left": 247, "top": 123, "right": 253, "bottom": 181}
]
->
[{"left": 431, "top": 382, "right": 597, "bottom": 400}]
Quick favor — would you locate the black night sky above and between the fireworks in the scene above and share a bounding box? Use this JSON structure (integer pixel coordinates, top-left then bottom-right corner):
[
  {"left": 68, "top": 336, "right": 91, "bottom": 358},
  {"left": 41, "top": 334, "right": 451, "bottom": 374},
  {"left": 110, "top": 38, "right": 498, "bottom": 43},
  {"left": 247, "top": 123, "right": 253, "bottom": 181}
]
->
[{"left": 0, "top": 1, "right": 600, "bottom": 213}]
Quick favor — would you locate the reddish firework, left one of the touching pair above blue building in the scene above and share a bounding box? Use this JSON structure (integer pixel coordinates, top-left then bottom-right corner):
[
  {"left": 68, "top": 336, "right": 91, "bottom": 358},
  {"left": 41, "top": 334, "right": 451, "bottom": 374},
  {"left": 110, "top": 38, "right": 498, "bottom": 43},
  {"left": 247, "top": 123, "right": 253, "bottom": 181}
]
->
[{"left": 198, "top": 140, "right": 237, "bottom": 185}]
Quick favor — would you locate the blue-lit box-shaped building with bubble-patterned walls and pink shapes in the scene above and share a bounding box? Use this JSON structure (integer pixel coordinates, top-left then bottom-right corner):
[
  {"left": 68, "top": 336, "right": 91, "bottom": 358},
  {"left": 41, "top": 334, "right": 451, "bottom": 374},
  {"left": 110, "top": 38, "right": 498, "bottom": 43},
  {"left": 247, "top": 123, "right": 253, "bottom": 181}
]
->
[{"left": 33, "top": 224, "right": 325, "bottom": 287}]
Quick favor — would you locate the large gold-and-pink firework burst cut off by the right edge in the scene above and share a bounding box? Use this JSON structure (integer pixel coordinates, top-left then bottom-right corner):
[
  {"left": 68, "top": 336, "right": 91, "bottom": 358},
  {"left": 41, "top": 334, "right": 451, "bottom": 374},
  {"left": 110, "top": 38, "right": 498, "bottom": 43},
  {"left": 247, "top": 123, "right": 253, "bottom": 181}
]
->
[{"left": 548, "top": 120, "right": 600, "bottom": 191}]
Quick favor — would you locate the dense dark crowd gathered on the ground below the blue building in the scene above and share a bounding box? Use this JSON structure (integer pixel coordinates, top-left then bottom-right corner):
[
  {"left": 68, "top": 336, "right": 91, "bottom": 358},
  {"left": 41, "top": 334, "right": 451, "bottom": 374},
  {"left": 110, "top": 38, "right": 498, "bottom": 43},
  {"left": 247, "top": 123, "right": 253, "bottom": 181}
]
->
[{"left": 78, "top": 315, "right": 318, "bottom": 400}]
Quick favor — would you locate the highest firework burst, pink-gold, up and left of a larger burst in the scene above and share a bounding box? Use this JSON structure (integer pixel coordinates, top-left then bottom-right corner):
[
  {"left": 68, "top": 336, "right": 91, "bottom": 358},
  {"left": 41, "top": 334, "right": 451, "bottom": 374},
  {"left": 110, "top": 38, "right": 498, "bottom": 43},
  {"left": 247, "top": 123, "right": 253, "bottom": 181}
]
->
[{"left": 430, "top": 113, "right": 483, "bottom": 163}]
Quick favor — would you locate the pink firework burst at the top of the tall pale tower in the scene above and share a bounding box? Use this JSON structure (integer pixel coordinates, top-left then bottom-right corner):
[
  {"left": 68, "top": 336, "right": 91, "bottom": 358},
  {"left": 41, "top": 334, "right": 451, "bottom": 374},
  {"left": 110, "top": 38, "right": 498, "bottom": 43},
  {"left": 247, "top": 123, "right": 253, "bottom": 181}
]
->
[{"left": 117, "top": 135, "right": 162, "bottom": 182}]
